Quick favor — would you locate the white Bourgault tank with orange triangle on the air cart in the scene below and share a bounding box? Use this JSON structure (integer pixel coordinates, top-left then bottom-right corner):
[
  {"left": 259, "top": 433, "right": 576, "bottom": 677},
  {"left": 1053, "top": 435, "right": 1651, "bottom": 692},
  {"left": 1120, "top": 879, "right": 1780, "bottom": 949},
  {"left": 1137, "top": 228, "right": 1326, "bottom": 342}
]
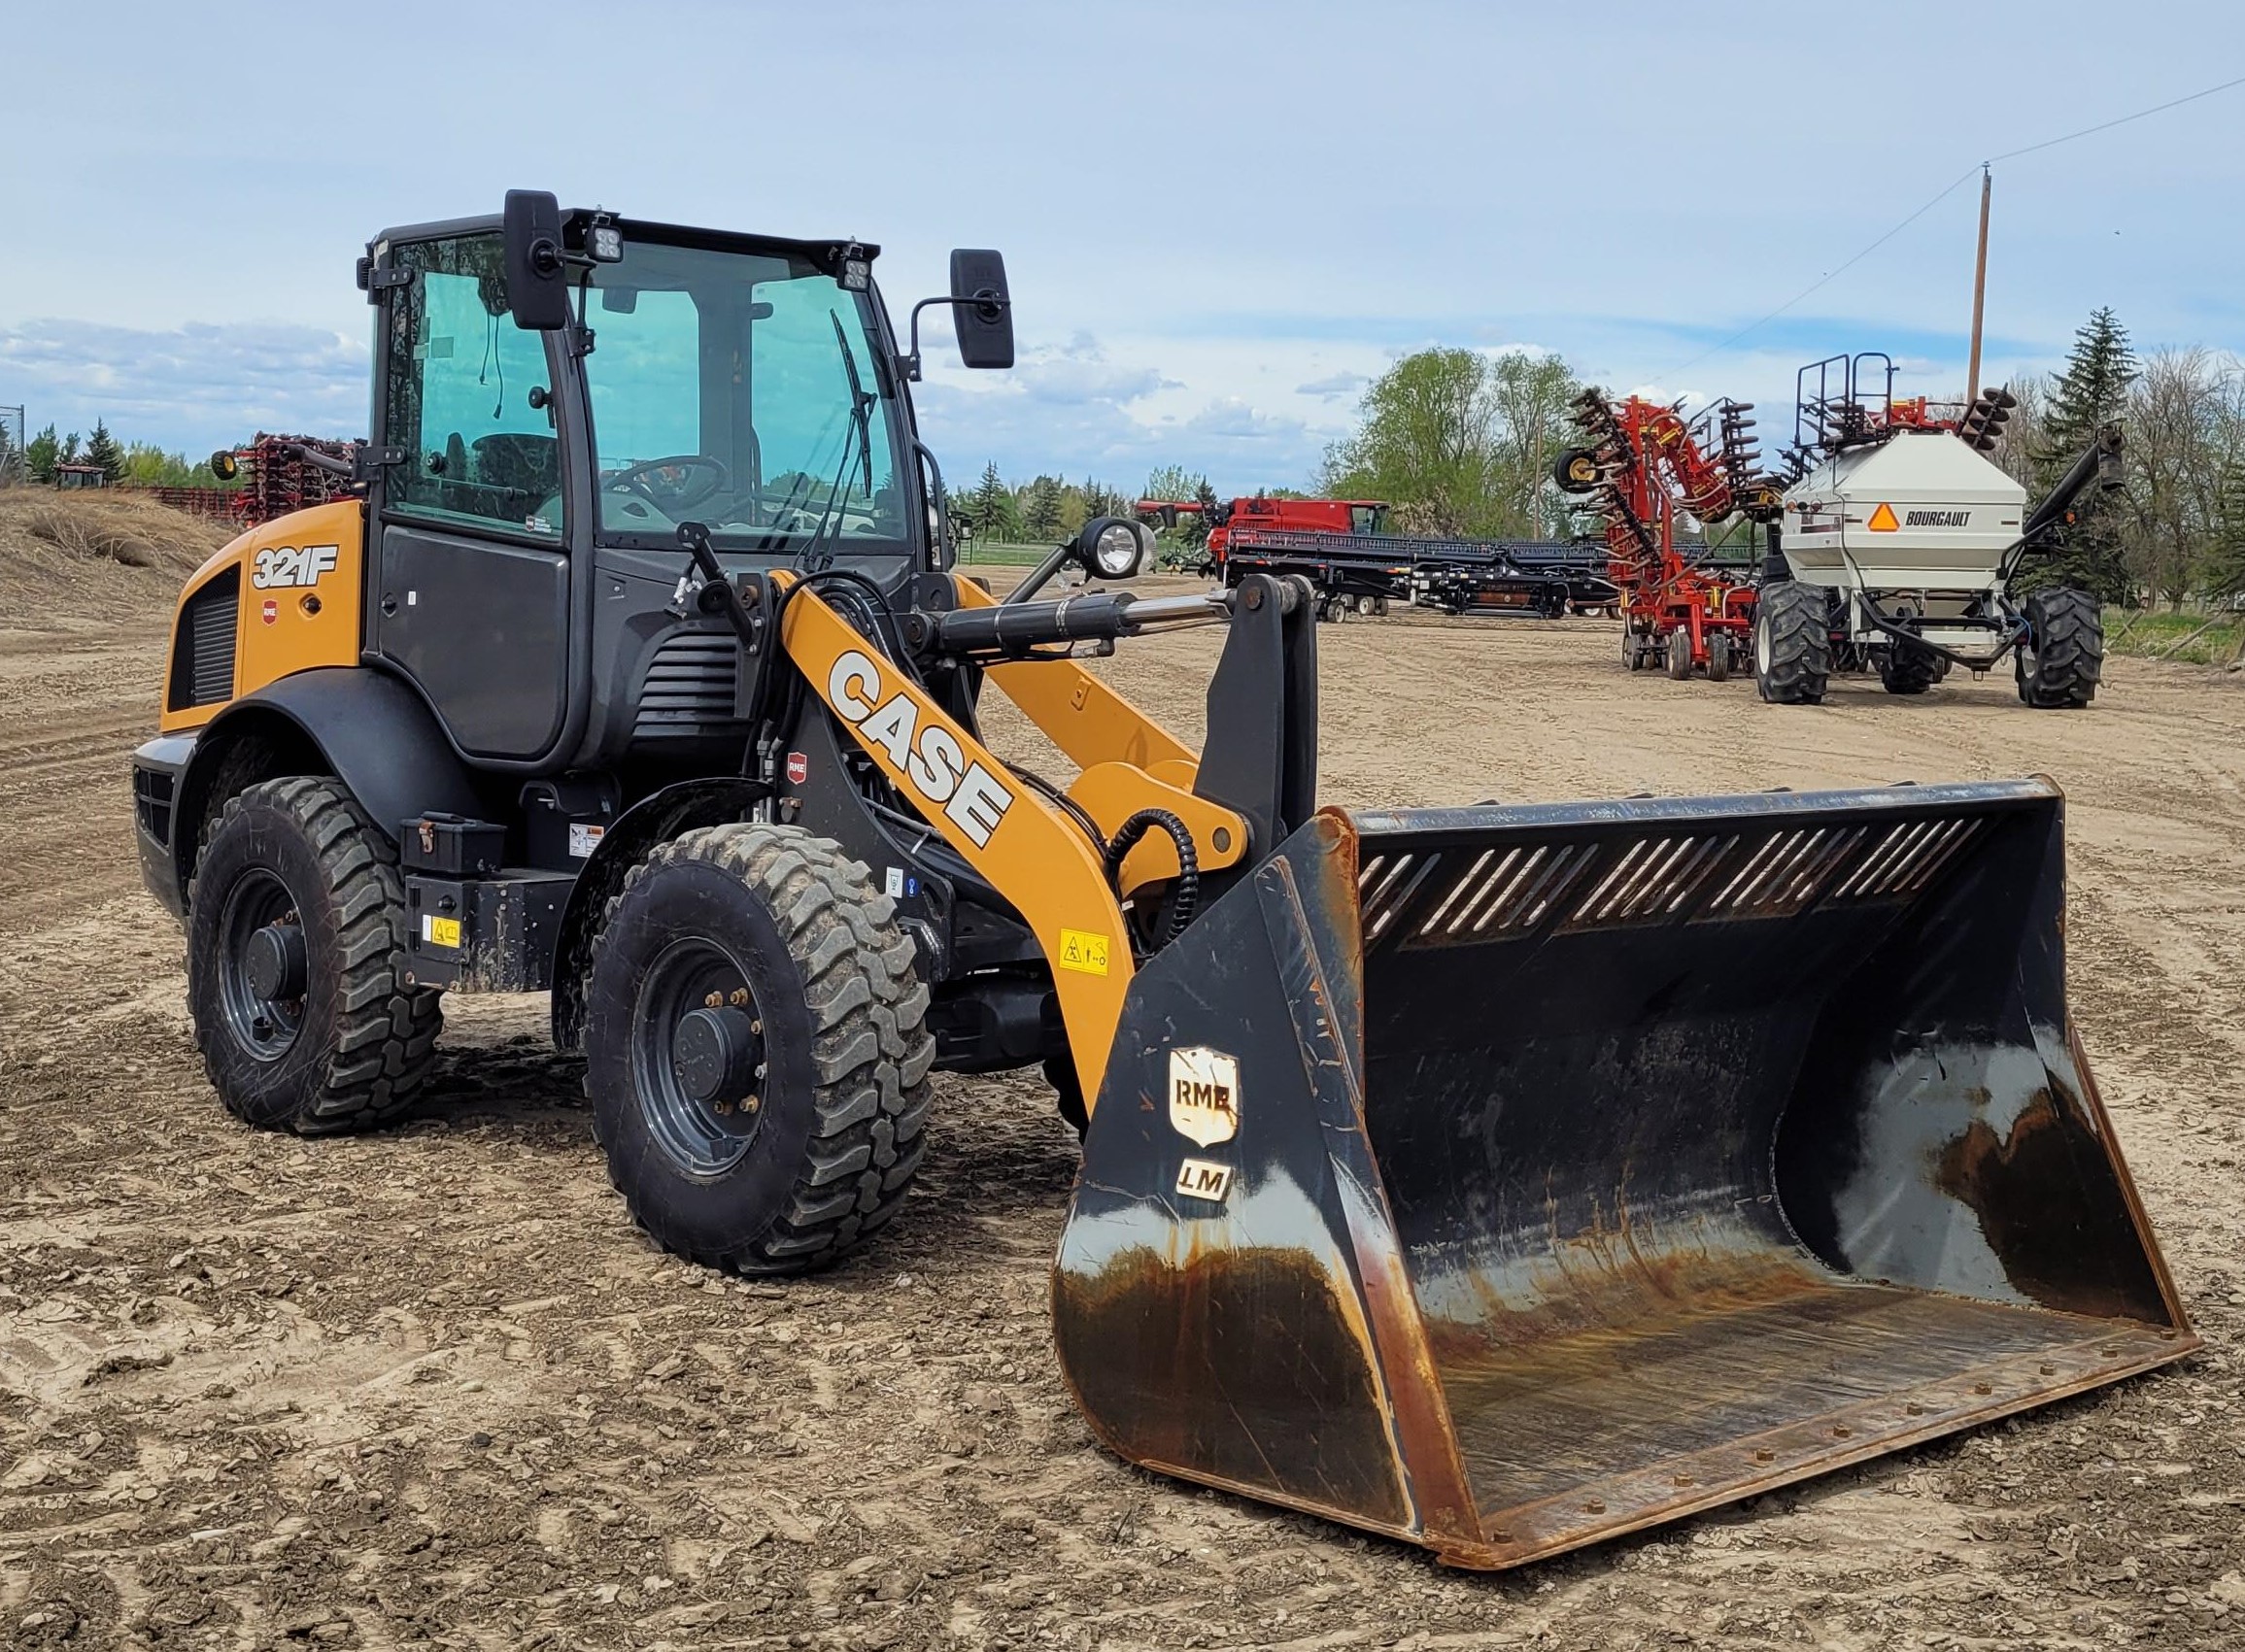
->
[{"left": 1783, "top": 428, "right": 2027, "bottom": 642}]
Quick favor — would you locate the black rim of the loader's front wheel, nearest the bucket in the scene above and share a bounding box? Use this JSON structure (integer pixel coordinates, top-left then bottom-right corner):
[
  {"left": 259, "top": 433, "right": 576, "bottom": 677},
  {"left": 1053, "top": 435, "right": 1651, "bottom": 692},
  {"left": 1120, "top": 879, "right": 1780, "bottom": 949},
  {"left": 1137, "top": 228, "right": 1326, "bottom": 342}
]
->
[{"left": 630, "top": 936, "right": 767, "bottom": 1176}]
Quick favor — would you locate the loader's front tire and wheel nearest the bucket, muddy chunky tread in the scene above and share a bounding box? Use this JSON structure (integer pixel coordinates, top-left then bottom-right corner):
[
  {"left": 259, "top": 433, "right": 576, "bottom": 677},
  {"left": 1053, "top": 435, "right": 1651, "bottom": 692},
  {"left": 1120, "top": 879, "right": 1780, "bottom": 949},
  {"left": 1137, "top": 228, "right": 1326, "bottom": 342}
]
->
[{"left": 584, "top": 824, "right": 936, "bottom": 1275}]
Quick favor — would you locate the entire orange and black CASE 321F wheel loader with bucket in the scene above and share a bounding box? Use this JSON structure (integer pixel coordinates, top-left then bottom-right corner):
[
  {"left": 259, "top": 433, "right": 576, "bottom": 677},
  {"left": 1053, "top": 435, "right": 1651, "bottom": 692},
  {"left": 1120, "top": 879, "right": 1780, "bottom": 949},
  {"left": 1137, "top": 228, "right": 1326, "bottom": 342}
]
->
[{"left": 135, "top": 193, "right": 2195, "bottom": 1567}]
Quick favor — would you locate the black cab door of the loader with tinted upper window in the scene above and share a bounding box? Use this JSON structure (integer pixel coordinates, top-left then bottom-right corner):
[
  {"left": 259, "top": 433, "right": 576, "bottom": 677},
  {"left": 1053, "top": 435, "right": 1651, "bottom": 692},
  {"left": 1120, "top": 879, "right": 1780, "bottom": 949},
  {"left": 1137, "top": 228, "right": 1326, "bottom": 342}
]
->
[{"left": 368, "top": 233, "right": 570, "bottom": 763}]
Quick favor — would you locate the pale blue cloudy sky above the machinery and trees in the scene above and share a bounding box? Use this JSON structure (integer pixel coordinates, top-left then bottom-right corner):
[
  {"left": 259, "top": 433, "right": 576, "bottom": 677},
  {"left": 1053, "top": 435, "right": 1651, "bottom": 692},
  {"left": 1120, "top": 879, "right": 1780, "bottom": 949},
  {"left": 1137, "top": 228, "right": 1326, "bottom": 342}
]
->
[{"left": 0, "top": 0, "right": 2245, "bottom": 491}]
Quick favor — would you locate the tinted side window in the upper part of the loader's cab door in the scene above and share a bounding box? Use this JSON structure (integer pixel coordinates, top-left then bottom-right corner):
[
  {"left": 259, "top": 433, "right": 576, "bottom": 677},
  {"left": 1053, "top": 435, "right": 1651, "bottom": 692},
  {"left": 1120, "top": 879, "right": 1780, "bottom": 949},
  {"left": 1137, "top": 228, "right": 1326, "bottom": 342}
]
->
[{"left": 384, "top": 236, "right": 561, "bottom": 539}]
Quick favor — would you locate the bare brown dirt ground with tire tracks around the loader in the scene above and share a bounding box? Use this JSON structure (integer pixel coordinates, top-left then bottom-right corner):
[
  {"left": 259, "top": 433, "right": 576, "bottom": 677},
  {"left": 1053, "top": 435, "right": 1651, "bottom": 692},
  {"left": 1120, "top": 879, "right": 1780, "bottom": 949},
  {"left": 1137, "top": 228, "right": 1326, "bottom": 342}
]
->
[{"left": 0, "top": 523, "right": 2245, "bottom": 1652}]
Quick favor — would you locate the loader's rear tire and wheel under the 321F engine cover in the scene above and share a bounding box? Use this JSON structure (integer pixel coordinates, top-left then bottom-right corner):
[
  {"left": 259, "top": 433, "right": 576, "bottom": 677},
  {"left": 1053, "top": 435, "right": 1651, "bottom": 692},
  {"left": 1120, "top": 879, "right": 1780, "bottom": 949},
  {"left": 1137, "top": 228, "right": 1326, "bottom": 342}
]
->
[{"left": 187, "top": 774, "right": 445, "bottom": 1135}]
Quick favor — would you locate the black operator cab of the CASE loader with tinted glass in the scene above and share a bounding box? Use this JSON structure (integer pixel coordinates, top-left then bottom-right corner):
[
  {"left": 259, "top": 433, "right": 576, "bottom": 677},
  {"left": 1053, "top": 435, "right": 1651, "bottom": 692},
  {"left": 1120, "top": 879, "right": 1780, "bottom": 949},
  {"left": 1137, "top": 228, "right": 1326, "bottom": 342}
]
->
[{"left": 361, "top": 190, "right": 1012, "bottom": 774}]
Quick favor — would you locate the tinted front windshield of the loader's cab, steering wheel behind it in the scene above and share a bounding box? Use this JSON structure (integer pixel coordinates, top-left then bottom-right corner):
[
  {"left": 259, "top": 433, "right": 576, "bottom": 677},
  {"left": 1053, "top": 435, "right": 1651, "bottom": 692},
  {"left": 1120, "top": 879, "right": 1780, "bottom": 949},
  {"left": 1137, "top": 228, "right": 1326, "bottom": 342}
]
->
[{"left": 584, "top": 240, "right": 909, "bottom": 556}]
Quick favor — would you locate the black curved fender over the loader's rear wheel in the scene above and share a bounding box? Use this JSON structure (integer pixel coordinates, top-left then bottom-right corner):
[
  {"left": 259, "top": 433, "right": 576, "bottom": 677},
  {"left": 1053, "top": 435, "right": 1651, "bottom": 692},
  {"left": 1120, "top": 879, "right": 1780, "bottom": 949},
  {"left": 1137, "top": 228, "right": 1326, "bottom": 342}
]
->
[{"left": 171, "top": 664, "right": 485, "bottom": 892}]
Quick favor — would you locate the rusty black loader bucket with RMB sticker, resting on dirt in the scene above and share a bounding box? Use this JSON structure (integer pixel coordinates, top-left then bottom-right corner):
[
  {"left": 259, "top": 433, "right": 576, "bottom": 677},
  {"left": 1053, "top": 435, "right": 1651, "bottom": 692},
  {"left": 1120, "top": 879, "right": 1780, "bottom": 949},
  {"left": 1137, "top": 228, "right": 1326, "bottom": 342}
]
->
[{"left": 1053, "top": 781, "right": 2195, "bottom": 1567}]
